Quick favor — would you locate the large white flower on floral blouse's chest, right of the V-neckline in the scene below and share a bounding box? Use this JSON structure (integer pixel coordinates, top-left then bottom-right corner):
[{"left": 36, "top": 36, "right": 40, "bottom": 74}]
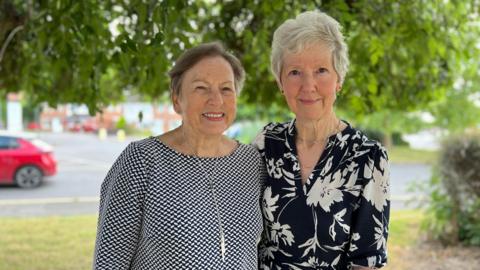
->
[{"left": 307, "top": 171, "right": 345, "bottom": 212}]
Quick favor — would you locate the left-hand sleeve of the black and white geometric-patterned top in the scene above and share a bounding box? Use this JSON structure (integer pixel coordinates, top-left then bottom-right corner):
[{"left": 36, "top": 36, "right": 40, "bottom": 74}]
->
[{"left": 93, "top": 143, "right": 146, "bottom": 269}]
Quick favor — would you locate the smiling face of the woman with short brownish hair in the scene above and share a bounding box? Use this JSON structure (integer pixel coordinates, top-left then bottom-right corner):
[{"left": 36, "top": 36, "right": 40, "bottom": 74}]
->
[{"left": 172, "top": 56, "right": 237, "bottom": 135}]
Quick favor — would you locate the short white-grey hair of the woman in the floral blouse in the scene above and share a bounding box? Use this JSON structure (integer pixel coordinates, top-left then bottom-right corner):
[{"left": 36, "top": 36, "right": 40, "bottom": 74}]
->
[{"left": 270, "top": 11, "right": 349, "bottom": 84}]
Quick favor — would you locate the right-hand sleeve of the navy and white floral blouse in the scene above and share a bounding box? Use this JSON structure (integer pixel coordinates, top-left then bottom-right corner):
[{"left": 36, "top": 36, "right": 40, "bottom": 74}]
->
[{"left": 347, "top": 144, "right": 390, "bottom": 268}]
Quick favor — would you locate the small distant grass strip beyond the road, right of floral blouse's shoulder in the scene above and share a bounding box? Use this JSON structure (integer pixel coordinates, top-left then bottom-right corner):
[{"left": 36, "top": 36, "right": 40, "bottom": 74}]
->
[{"left": 387, "top": 146, "right": 438, "bottom": 164}]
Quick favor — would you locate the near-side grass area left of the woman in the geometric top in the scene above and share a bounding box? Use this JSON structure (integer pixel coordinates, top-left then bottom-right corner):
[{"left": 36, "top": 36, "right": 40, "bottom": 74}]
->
[{"left": 0, "top": 216, "right": 97, "bottom": 270}]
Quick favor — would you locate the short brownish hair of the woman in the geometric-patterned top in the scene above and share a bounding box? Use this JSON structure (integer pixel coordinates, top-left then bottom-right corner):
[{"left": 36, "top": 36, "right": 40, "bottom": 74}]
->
[{"left": 168, "top": 41, "right": 245, "bottom": 96}]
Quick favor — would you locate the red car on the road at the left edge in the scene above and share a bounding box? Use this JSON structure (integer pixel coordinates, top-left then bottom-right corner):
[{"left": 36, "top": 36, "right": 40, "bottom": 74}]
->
[{"left": 0, "top": 133, "right": 57, "bottom": 188}]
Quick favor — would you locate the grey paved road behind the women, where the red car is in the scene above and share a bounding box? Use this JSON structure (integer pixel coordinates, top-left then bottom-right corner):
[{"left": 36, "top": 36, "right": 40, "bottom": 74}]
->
[{"left": 0, "top": 133, "right": 430, "bottom": 217}]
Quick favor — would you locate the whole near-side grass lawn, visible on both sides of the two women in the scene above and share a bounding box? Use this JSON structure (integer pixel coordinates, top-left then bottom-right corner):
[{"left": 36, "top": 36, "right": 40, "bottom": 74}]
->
[{"left": 0, "top": 210, "right": 422, "bottom": 270}]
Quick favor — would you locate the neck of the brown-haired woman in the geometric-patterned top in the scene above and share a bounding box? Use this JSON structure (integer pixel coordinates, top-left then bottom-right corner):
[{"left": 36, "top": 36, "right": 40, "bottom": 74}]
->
[{"left": 178, "top": 125, "right": 223, "bottom": 157}]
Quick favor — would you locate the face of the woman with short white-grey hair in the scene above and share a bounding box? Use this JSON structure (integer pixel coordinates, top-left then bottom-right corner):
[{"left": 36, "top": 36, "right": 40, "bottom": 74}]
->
[{"left": 279, "top": 44, "right": 340, "bottom": 120}]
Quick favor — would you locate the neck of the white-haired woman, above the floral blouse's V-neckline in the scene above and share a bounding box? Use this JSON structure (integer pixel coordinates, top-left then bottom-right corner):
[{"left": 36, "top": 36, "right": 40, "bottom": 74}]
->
[{"left": 295, "top": 114, "right": 341, "bottom": 142}]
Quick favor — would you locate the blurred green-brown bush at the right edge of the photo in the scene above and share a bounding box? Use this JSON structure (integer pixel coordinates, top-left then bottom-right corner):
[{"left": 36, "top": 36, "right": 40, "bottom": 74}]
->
[{"left": 424, "top": 134, "right": 480, "bottom": 246}]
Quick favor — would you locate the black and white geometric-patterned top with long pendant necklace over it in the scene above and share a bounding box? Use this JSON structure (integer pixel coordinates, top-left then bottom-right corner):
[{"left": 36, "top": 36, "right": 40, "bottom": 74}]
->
[{"left": 94, "top": 137, "right": 263, "bottom": 270}]
